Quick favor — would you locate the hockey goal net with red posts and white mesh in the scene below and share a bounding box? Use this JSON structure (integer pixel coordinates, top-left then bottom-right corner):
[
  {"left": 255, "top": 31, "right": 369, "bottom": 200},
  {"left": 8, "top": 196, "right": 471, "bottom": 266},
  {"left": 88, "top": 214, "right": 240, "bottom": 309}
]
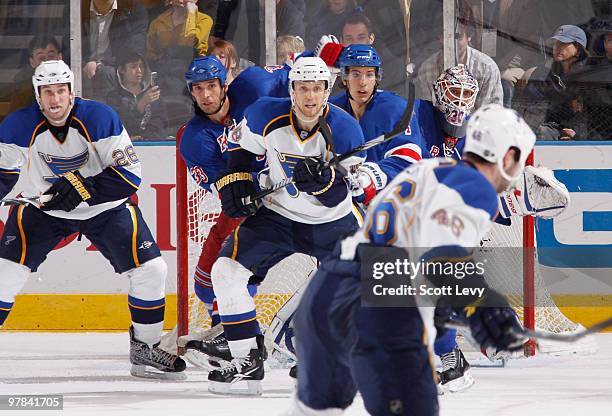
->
[{"left": 177, "top": 141, "right": 597, "bottom": 356}]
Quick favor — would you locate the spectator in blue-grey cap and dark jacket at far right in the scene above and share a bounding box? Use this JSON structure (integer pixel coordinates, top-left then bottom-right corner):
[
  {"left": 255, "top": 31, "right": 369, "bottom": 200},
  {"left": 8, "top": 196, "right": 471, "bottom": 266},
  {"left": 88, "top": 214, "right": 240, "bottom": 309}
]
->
[{"left": 523, "top": 25, "right": 588, "bottom": 140}]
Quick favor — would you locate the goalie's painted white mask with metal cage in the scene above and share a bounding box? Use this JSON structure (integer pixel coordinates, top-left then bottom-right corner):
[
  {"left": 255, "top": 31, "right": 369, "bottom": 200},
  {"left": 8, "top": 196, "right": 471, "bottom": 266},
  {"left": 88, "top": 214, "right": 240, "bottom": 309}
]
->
[{"left": 433, "top": 64, "right": 479, "bottom": 126}]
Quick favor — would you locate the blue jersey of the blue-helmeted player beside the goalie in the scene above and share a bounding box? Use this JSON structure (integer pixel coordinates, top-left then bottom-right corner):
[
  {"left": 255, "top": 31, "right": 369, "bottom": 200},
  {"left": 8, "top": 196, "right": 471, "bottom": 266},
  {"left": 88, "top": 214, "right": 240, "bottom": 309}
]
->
[{"left": 330, "top": 90, "right": 427, "bottom": 181}]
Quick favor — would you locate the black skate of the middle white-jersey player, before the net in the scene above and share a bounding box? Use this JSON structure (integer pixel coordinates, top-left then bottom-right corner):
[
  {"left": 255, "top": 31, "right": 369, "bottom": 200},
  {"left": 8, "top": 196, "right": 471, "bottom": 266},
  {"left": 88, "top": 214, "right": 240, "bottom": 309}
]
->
[{"left": 208, "top": 335, "right": 265, "bottom": 396}]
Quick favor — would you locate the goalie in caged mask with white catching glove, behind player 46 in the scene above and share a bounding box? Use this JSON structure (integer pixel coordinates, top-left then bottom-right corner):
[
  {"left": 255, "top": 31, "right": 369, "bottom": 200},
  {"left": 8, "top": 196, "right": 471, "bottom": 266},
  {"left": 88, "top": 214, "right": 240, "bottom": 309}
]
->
[{"left": 415, "top": 64, "right": 569, "bottom": 392}]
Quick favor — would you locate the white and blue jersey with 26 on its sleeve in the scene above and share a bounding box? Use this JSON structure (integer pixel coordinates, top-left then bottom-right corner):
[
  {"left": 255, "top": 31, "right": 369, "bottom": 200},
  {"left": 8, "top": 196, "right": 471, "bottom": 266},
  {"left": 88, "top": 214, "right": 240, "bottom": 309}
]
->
[{"left": 0, "top": 98, "right": 141, "bottom": 219}]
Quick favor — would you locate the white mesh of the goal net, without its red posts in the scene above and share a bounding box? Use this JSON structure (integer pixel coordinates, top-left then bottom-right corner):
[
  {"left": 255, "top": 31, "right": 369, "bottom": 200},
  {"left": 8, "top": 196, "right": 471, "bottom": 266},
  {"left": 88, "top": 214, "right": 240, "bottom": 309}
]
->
[{"left": 179, "top": 175, "right": 597, "bottom": 354}]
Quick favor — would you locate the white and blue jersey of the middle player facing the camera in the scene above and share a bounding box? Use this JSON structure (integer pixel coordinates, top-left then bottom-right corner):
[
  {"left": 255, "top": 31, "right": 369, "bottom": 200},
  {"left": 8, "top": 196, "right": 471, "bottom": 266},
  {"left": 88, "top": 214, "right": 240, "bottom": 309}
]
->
[{"left": 234, "top": 98, "right": 364, "bottom": 224}]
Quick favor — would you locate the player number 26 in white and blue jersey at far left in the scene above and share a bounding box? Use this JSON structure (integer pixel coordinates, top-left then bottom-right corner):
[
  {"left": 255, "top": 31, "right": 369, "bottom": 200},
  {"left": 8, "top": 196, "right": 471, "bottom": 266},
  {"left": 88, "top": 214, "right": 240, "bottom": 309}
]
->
[{"left": 0, "top": 61, "right": 185, "bottom": 378}]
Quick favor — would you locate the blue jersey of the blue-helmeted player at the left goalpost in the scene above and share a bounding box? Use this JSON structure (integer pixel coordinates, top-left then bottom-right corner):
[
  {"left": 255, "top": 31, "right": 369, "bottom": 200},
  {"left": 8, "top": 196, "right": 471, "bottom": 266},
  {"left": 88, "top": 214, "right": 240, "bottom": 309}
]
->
[{"left": 179, "top": 78, "right": 264, "bottom": 191}]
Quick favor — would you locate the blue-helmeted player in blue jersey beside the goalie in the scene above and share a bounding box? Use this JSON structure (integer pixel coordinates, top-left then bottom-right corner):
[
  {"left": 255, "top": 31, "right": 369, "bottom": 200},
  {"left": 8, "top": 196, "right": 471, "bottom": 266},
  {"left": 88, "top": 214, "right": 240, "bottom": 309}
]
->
[{"left": 330, "top": 45, "right": 424, "bottom": 205}]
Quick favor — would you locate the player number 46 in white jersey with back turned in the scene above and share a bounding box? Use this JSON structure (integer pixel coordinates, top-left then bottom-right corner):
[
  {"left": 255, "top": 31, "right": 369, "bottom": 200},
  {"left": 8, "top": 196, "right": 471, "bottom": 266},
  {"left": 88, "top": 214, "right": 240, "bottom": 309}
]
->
[{"left": 287, "top": 105, "right": 535, "bottom": 416}]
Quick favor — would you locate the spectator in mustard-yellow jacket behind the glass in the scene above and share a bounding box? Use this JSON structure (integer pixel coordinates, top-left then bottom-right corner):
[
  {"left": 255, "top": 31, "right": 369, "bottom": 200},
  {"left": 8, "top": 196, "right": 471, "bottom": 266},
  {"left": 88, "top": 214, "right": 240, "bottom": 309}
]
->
[{"left": 147, "top": 0, "right": 212, "bottom": 65}]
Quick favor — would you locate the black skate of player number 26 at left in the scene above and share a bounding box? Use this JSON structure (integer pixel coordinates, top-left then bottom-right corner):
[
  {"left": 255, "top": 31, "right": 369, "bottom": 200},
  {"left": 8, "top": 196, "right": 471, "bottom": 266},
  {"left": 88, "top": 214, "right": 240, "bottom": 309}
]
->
[{"left": 130, "top": 327, "right": 187, "bottom": 380}]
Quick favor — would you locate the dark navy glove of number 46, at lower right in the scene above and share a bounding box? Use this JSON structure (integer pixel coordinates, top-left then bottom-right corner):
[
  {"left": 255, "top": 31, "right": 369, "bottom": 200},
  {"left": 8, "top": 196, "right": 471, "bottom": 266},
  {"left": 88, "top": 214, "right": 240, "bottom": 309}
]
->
[{"left": 465, "top": 290, "right": 526, "bottom": 351}]
